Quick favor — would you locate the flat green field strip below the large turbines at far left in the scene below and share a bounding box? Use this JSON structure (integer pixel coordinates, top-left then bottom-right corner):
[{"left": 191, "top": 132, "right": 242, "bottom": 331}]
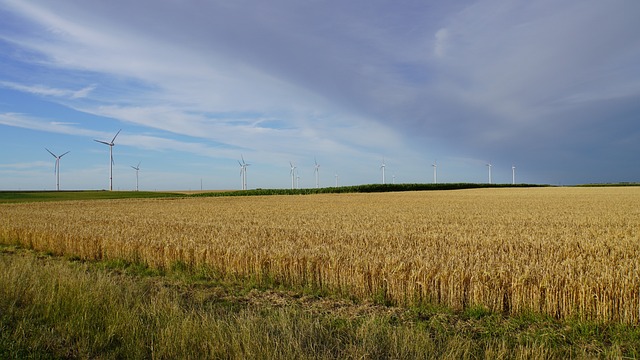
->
[{"left": 0, "top": 190, "right": 184, "bottom": 204}]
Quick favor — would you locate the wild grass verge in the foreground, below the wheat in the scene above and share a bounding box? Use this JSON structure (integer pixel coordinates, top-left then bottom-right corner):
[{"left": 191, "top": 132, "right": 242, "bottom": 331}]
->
[{"left": 0, "top": 246, "right": 640, "bottom": 359}]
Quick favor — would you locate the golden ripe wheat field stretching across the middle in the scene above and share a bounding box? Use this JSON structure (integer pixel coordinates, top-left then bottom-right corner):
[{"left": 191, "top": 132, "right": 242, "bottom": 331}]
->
[{"left": 0, "top": 187, "right": 640, "bottom": 323}]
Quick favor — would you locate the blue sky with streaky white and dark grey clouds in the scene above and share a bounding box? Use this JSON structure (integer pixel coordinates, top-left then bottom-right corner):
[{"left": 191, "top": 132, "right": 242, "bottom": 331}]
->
[{"left": 0, "top": 0, "right": 640, "bottom": 190}]
